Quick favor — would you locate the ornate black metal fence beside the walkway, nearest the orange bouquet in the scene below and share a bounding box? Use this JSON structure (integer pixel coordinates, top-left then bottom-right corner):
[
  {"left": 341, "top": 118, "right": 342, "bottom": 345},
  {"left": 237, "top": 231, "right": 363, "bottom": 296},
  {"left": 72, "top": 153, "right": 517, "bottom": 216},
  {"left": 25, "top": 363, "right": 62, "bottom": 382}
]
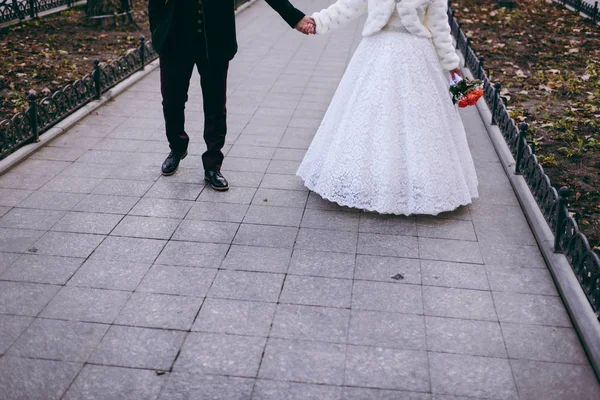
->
[{"left": 448, "top": 3, "right": 600, "bottom": 312}]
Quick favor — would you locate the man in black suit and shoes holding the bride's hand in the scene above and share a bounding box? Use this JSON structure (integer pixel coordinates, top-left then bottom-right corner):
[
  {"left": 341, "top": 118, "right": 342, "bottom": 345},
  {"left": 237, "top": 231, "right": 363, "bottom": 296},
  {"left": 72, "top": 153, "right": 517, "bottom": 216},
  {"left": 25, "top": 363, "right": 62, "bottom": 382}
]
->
[{"left": 148, "top": 0, "right": 313, "bottom": 191}]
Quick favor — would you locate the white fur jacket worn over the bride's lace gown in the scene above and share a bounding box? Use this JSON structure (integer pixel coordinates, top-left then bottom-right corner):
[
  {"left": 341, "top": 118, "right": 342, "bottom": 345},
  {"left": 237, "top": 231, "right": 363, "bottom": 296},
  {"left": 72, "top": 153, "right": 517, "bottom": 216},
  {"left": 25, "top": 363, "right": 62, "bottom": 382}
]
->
[{"left": 312, "top": 0, "right": 459, "bottom": 71}]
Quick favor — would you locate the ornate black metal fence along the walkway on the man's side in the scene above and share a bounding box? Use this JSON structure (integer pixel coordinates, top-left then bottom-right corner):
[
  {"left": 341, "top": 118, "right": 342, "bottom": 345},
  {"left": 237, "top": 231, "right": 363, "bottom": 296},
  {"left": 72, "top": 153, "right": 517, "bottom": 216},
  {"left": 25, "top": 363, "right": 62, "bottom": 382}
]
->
[{"left": 0, "top": 37, "right": 158, "bottom": 160}]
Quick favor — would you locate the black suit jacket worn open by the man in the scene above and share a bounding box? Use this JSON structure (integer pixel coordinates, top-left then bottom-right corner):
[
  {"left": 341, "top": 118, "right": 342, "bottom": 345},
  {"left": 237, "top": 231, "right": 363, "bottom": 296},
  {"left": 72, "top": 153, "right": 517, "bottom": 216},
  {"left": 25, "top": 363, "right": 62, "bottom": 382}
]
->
[{"left": 148, "top": 0, "right": 304, "bottom": 60}]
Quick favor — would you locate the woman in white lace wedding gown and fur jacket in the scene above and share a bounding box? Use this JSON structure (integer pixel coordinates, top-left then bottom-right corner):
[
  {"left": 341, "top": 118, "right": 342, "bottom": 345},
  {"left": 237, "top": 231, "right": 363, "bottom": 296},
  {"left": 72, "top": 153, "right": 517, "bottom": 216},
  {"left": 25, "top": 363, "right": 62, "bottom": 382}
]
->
[{"left": 297, "top": 0, "right": 478, "bottom": 215}]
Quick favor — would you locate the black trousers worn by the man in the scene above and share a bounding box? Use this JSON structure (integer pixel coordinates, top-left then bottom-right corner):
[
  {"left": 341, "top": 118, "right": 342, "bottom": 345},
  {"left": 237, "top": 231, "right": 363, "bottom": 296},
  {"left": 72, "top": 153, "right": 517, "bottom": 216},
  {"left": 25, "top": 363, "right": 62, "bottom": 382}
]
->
[{"left": 160, "top": 49, "right": 229, "bottom": 171}]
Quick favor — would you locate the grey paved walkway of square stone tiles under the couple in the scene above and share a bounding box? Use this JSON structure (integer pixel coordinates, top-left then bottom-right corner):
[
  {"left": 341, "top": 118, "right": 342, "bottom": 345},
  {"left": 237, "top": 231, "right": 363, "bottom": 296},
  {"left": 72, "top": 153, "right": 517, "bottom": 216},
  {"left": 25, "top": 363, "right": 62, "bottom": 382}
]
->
[{"left": 0, "top": 0, "right": 600, "bottom": 400}]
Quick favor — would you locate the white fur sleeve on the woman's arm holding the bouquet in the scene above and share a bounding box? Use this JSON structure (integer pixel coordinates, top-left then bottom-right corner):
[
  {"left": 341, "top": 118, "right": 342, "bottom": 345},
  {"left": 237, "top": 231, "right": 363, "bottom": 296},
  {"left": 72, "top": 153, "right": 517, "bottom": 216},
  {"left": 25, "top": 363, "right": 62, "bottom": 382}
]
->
[{"left": 425, "top": 0, "right": 460, "bottom": 71}]
